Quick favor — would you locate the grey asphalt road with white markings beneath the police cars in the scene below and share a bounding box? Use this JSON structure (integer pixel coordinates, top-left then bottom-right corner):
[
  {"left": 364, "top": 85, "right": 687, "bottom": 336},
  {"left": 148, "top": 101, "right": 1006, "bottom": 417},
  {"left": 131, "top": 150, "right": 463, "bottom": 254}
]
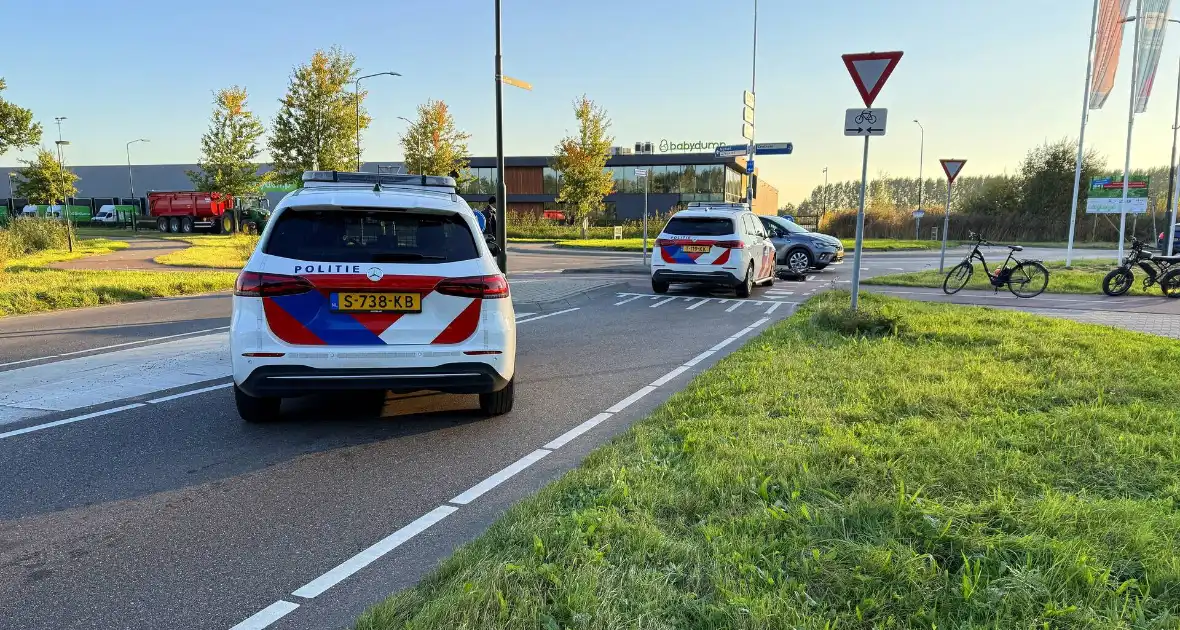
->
[{"left": 0, "top": 239, "right": 1132, "bottom": 630}]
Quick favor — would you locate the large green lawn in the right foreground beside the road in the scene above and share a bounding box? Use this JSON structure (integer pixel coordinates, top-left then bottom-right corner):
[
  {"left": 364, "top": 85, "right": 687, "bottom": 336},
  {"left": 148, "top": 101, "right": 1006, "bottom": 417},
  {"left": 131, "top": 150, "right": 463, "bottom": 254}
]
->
[{"left": 356, "top": 293, "right": 1180, "bottom": 630}]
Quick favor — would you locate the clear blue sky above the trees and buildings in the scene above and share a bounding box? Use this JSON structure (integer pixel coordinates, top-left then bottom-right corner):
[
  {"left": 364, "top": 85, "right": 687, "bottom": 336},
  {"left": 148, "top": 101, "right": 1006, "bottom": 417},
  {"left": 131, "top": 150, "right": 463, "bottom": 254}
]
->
[{"left": 0, "top": 0, "right": 1180, "bottom": 201}]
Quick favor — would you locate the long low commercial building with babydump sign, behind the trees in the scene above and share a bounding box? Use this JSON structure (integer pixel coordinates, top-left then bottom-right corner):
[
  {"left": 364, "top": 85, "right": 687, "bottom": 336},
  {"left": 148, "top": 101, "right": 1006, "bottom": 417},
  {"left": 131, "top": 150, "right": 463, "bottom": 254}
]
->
[{"left": 0, "top": 153, "right": 779, "bottom": 222}]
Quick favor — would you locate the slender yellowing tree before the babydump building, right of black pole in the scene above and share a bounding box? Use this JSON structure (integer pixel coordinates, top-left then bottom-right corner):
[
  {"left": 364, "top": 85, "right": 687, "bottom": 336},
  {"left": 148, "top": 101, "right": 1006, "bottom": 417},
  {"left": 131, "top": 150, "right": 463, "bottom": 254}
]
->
[{"left": 553, "top": 94, "right": 615, "bottom": 238}]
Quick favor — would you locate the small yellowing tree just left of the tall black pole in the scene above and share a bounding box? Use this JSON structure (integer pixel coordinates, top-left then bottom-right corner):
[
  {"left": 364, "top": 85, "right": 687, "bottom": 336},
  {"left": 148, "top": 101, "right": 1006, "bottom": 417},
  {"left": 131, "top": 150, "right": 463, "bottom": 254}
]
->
[{"left": 401, "top": 99, "right": 471, "bottom": 177}]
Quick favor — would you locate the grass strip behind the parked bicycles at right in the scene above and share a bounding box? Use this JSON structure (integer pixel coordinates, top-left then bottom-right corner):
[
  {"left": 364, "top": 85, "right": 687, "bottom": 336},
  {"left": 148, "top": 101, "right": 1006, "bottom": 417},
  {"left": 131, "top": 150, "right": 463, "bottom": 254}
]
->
[{"left": 861, "top": 258, "right": 1142, "bottom": 295}]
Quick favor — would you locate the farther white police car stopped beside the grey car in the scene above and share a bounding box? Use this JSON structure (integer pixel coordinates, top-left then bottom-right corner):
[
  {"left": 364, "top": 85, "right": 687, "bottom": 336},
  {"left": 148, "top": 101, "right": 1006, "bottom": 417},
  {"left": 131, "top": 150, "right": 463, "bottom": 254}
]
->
[{"left": 651, "top": 202, "right": 775, "bottom": 297}]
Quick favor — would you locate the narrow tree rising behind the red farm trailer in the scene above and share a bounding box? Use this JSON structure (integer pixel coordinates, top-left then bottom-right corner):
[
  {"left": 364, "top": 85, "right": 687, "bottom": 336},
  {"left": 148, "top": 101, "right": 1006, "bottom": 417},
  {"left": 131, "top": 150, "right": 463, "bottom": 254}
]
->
[{"left": 188, "top": 85, "right": 266, "bottom": 196}]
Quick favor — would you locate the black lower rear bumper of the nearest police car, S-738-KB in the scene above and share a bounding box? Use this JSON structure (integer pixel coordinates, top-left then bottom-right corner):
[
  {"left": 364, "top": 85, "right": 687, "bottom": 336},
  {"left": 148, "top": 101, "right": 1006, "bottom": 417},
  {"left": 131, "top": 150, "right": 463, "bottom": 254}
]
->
[{"left": 238, "top": 362, "right": 509, "bottom": 398}]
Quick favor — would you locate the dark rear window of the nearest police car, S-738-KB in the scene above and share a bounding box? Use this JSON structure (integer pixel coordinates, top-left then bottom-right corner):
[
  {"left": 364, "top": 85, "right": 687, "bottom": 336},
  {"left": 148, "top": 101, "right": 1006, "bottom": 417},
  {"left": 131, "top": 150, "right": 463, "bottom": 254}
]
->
[{"left": 263, "top": 209, "right": 479, "bottom": 264}]
